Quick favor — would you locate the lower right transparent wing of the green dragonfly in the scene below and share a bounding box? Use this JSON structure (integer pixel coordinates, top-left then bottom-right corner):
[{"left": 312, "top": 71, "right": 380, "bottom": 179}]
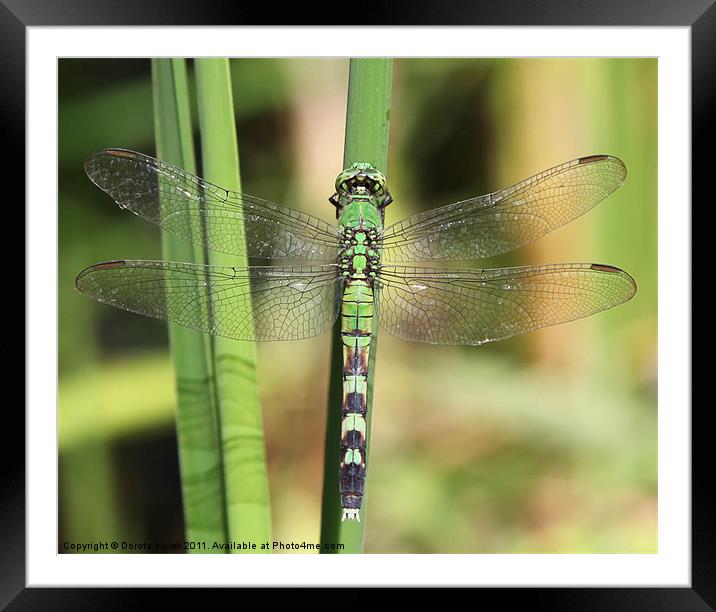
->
[{"left": 379, "top": 264, "right": 636, "bottom": 345}]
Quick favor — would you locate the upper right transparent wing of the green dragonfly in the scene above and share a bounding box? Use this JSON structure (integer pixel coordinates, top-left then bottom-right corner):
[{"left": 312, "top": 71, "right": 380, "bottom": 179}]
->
[{"left": 382, "top": 155, "right": 626, "bottom": 263}]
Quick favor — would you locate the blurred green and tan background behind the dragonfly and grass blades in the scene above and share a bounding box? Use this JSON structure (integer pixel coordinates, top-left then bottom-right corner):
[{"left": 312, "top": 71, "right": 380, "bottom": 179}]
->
[{"left": 58, "top": 59, "right": 657, "bottom": 553}]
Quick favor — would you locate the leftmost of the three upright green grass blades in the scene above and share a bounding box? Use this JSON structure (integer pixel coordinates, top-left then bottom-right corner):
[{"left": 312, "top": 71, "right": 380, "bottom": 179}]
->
[{"left": 152, "top": 59, "right": 227, "bottom": 552}]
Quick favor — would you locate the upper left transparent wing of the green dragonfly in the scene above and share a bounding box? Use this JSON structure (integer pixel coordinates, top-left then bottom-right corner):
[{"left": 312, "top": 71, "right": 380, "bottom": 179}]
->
[{"left": 85, "top": 149, "right": 338, "bottom": 262}]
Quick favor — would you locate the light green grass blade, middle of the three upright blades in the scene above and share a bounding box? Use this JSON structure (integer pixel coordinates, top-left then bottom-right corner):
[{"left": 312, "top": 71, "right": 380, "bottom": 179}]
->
[{"left": 194, "top": 58, "right": 271, "bottom": 552}]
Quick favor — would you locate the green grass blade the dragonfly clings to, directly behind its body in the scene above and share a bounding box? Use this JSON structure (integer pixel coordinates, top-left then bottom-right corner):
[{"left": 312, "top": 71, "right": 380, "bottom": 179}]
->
[{"left": 321, "top": 59, "right": 393, "bottom": 553}]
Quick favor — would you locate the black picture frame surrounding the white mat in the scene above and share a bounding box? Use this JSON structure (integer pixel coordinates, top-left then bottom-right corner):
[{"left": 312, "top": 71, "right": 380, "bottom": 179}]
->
[{"left": 11, "top": 0, "right": 704, "bottom": 611}]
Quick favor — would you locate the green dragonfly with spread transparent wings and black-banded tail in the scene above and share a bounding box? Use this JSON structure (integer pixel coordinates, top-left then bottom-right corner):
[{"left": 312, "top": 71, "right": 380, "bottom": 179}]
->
[{"left": 75, "top": 149, "right": 636, "bottom": 521}]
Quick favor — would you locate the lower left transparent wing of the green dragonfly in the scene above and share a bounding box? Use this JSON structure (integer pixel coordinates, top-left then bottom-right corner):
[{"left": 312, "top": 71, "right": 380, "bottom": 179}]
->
[{"left": 75, "top": 260, "right": 343, "bottom": 340}]
